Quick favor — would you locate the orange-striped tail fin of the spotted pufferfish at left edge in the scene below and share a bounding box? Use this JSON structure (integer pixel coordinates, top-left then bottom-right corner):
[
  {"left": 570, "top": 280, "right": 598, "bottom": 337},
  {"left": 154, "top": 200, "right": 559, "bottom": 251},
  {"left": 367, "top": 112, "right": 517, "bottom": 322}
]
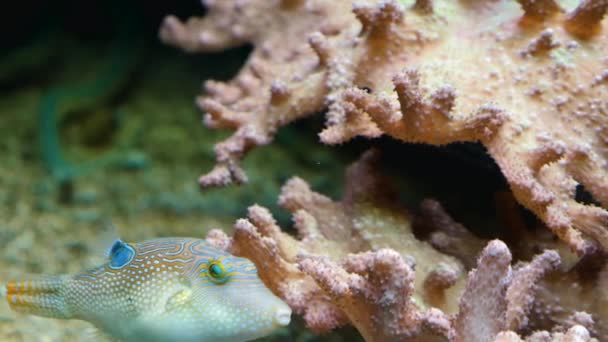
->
[{"left": 0, "top": 276, "right": 72, "bottom": 319}]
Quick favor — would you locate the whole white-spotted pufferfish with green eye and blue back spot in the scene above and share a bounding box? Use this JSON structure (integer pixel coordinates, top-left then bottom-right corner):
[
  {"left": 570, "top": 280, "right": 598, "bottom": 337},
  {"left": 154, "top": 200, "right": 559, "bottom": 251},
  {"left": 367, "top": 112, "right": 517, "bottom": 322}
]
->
[{"left": 4, "top": 238, "right": 291, "bottom": 342}]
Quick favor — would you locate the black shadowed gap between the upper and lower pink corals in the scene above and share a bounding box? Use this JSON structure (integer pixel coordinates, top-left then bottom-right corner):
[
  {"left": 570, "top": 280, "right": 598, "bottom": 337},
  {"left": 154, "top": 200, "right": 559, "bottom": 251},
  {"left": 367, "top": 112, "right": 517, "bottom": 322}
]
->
[{"left": 372, "top": 138, "right": 509, "bottom": 236}]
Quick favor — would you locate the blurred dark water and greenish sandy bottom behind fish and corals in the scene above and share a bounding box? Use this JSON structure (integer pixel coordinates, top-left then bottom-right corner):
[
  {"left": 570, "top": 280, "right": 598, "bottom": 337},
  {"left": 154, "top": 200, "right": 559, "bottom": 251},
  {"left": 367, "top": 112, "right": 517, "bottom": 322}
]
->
[{"left": 0, "top": 0, "right": 532, "bottom": 341}]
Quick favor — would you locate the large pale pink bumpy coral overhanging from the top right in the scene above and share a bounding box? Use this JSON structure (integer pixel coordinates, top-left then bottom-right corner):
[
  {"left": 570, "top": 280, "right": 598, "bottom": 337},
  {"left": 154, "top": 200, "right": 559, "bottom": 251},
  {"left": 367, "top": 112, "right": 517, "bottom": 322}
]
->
[{"left": 160, "top": 0, "right": 608, "bottom": 254}]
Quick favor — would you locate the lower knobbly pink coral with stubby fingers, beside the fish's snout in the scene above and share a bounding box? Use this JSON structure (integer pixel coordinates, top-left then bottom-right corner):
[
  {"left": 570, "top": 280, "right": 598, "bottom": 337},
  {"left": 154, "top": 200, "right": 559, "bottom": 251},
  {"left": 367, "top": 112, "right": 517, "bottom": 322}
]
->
[{"left": 208, "top": 151, "right": 594, "bottom": 341}]
